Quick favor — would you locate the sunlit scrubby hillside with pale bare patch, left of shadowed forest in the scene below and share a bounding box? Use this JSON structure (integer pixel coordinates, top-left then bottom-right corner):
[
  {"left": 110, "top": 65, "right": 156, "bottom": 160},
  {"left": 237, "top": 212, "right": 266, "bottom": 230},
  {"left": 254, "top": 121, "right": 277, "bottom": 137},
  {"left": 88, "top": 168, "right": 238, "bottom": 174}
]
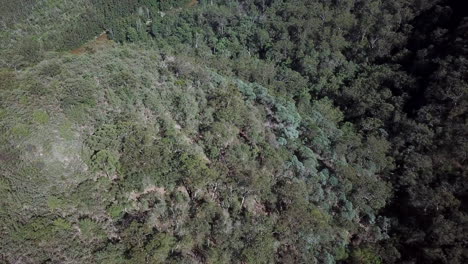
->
[{"left": 0, "top": 45, "right": 388, "bottom": 263}]
